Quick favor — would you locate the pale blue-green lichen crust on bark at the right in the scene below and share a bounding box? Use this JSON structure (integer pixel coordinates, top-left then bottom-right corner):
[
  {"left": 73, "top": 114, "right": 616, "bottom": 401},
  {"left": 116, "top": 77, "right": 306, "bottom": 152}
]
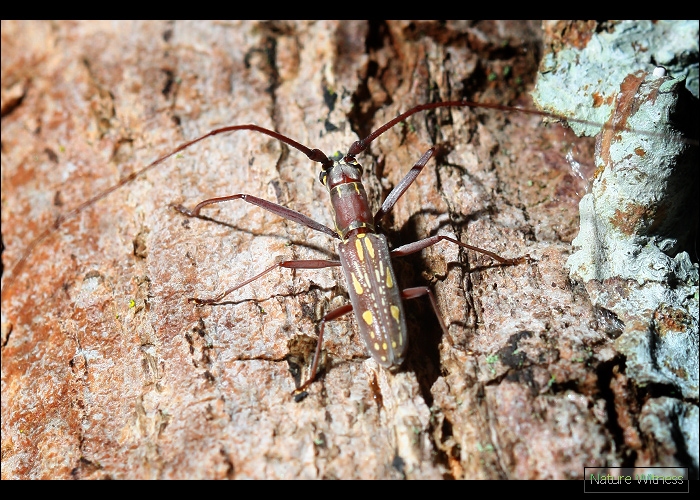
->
[{"left": 536, "top": 21, "right": 700, "bottom": 475}]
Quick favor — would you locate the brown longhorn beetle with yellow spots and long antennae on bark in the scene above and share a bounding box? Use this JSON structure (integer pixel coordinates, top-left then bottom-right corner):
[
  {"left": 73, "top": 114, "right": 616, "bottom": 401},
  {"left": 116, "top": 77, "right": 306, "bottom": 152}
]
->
[{"left": 3, "top": 89, "right": 676, "bottom": 394}]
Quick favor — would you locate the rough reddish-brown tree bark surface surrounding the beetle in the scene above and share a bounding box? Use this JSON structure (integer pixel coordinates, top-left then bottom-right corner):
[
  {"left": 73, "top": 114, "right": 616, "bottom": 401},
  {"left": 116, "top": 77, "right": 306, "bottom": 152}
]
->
[{"left": 2, "top": 21, "right": 688, "bottom": 479}]
